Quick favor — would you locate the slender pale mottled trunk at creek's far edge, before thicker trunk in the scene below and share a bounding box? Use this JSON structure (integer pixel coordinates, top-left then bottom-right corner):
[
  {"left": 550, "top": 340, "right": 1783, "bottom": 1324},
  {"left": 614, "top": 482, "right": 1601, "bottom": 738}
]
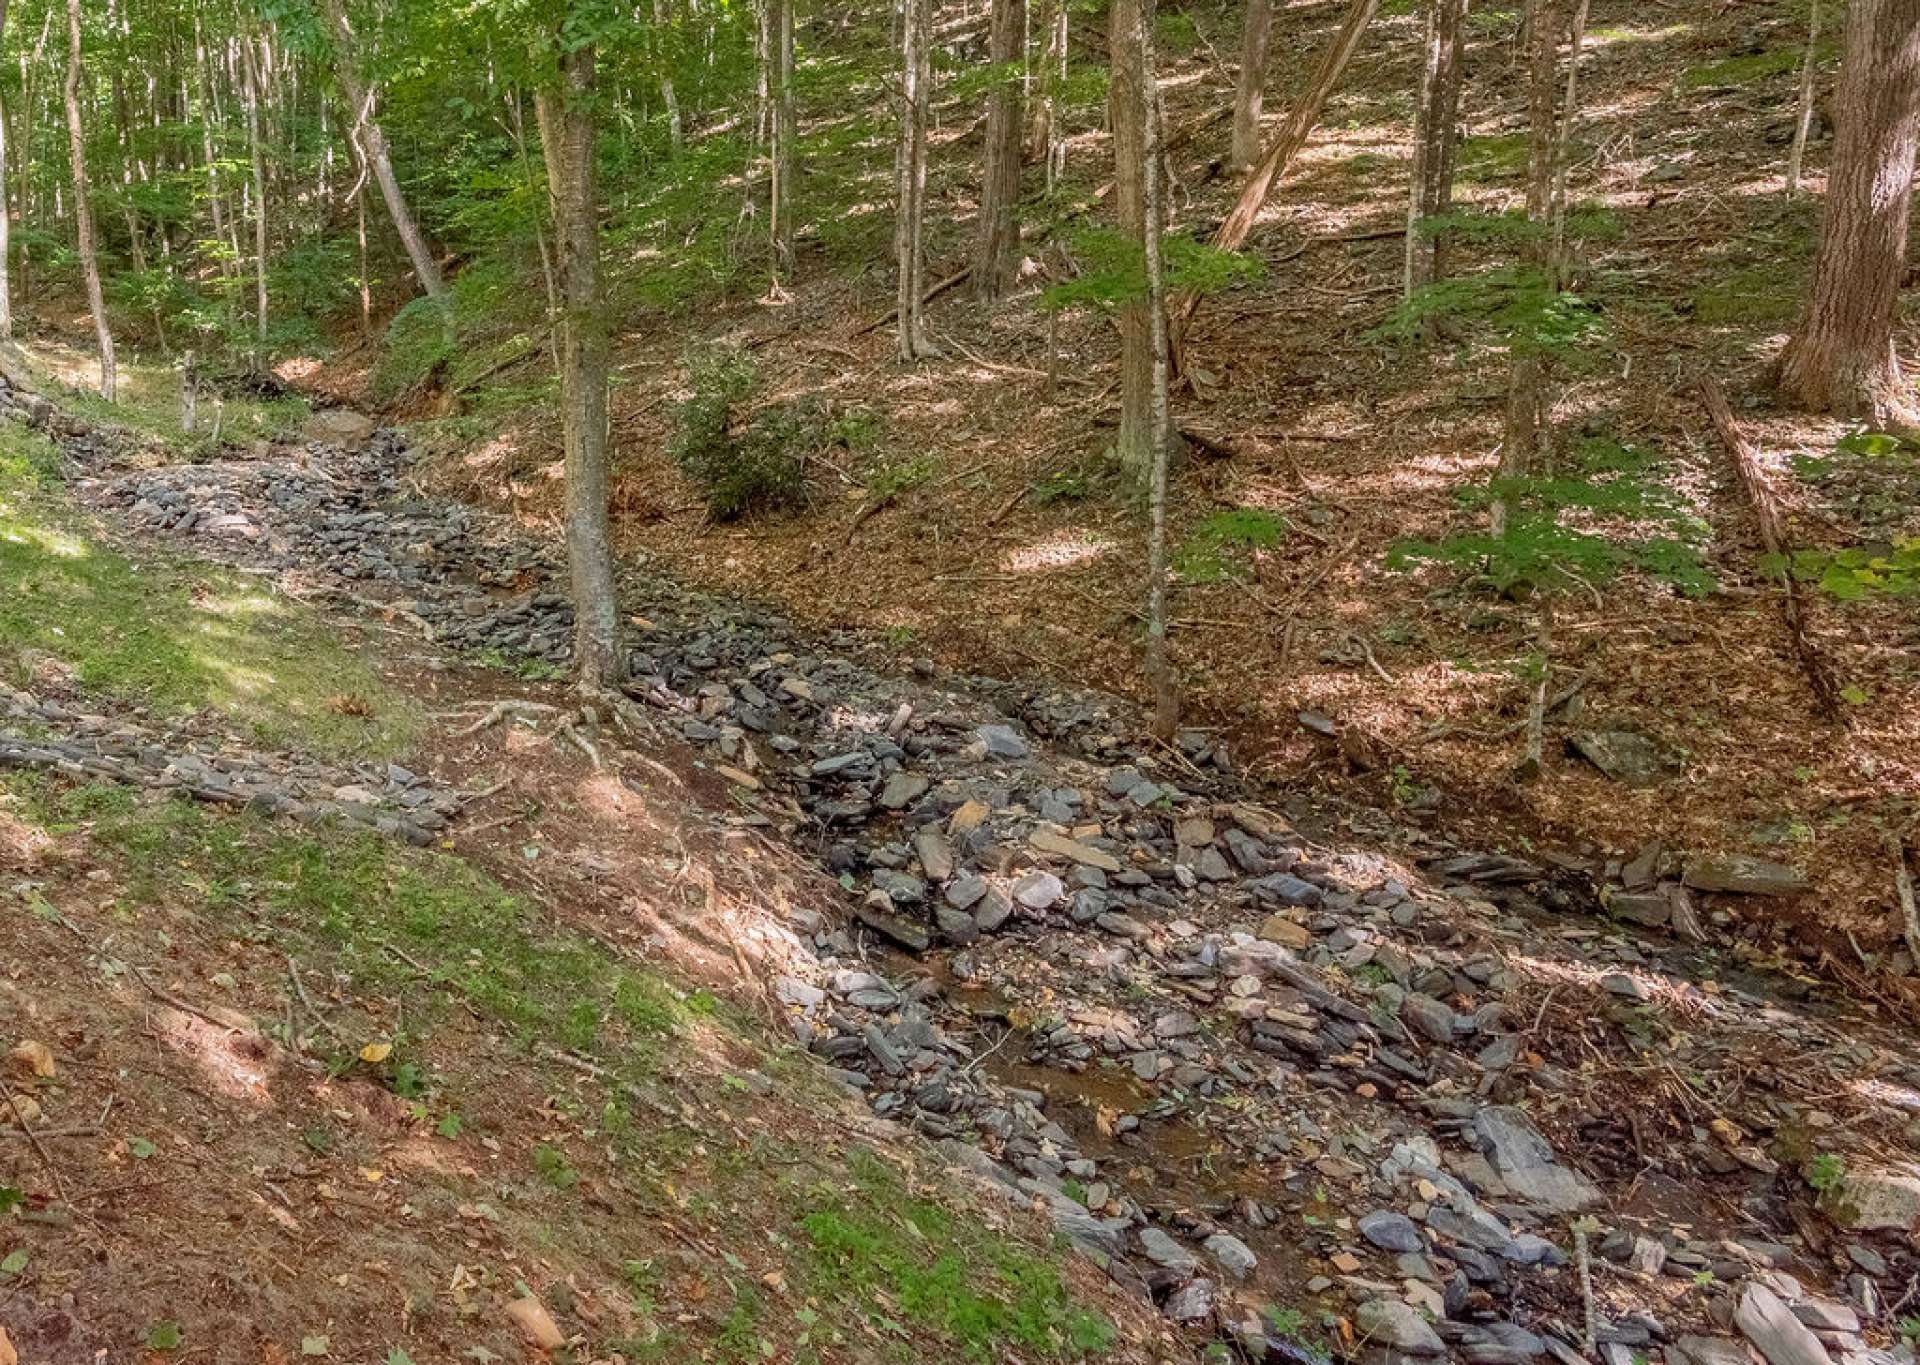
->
[{"left": 1133, "top": 0, "right": 1181, "bottom": 739}]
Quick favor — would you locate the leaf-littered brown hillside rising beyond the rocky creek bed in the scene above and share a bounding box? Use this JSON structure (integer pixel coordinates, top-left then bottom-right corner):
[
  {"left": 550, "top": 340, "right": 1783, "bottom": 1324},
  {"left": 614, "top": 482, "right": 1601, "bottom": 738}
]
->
[{"left": 323, "top": 2, "right": 1920, "bottom": 971}]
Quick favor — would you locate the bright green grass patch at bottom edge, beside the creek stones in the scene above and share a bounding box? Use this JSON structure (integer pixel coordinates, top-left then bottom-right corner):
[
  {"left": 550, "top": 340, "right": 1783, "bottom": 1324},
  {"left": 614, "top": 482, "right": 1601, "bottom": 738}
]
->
[{"left": 799, "top": 1152, "right": 1114, "bottom": 1361}]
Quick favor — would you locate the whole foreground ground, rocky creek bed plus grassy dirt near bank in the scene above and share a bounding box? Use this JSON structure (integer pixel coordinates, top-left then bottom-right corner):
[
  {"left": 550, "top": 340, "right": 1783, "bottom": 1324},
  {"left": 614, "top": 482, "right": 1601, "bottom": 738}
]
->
[{"left": 11, "top": 330, "right": 1920, "bottom": 1365}]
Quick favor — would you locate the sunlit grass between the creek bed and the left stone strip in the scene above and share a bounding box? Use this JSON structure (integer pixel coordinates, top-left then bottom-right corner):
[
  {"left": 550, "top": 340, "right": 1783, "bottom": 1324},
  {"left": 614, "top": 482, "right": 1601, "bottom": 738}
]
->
[{"left": 0, "top": 426, "right": 419, "bottom": 754}]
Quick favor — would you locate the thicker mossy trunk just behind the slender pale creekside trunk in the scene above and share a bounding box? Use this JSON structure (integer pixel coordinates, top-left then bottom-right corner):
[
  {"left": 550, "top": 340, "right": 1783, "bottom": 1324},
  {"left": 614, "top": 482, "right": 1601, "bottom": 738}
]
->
[{"left": 1106, "top": 0, "right": 1165, "bottom": 488}]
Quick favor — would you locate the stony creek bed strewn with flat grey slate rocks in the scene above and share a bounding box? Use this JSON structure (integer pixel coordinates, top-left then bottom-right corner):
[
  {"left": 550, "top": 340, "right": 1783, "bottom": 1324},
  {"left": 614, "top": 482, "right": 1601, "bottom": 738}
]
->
[{"left": 15, "top": 374, "right": 1920, "bottom": 1365}]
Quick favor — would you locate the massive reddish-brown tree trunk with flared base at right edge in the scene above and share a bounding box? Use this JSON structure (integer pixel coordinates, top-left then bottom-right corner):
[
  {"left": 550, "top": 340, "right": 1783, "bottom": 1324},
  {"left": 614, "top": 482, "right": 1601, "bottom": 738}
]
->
[{"left": 1780, "top": 0, "right": 1920, "bottom": 426}]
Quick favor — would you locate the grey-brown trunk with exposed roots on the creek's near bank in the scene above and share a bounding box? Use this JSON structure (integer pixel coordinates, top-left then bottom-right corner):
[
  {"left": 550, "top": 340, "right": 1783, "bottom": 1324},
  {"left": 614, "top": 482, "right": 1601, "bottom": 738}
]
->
[{"left": 533, "top": 46, "right": 626, "bottom": 691}]
